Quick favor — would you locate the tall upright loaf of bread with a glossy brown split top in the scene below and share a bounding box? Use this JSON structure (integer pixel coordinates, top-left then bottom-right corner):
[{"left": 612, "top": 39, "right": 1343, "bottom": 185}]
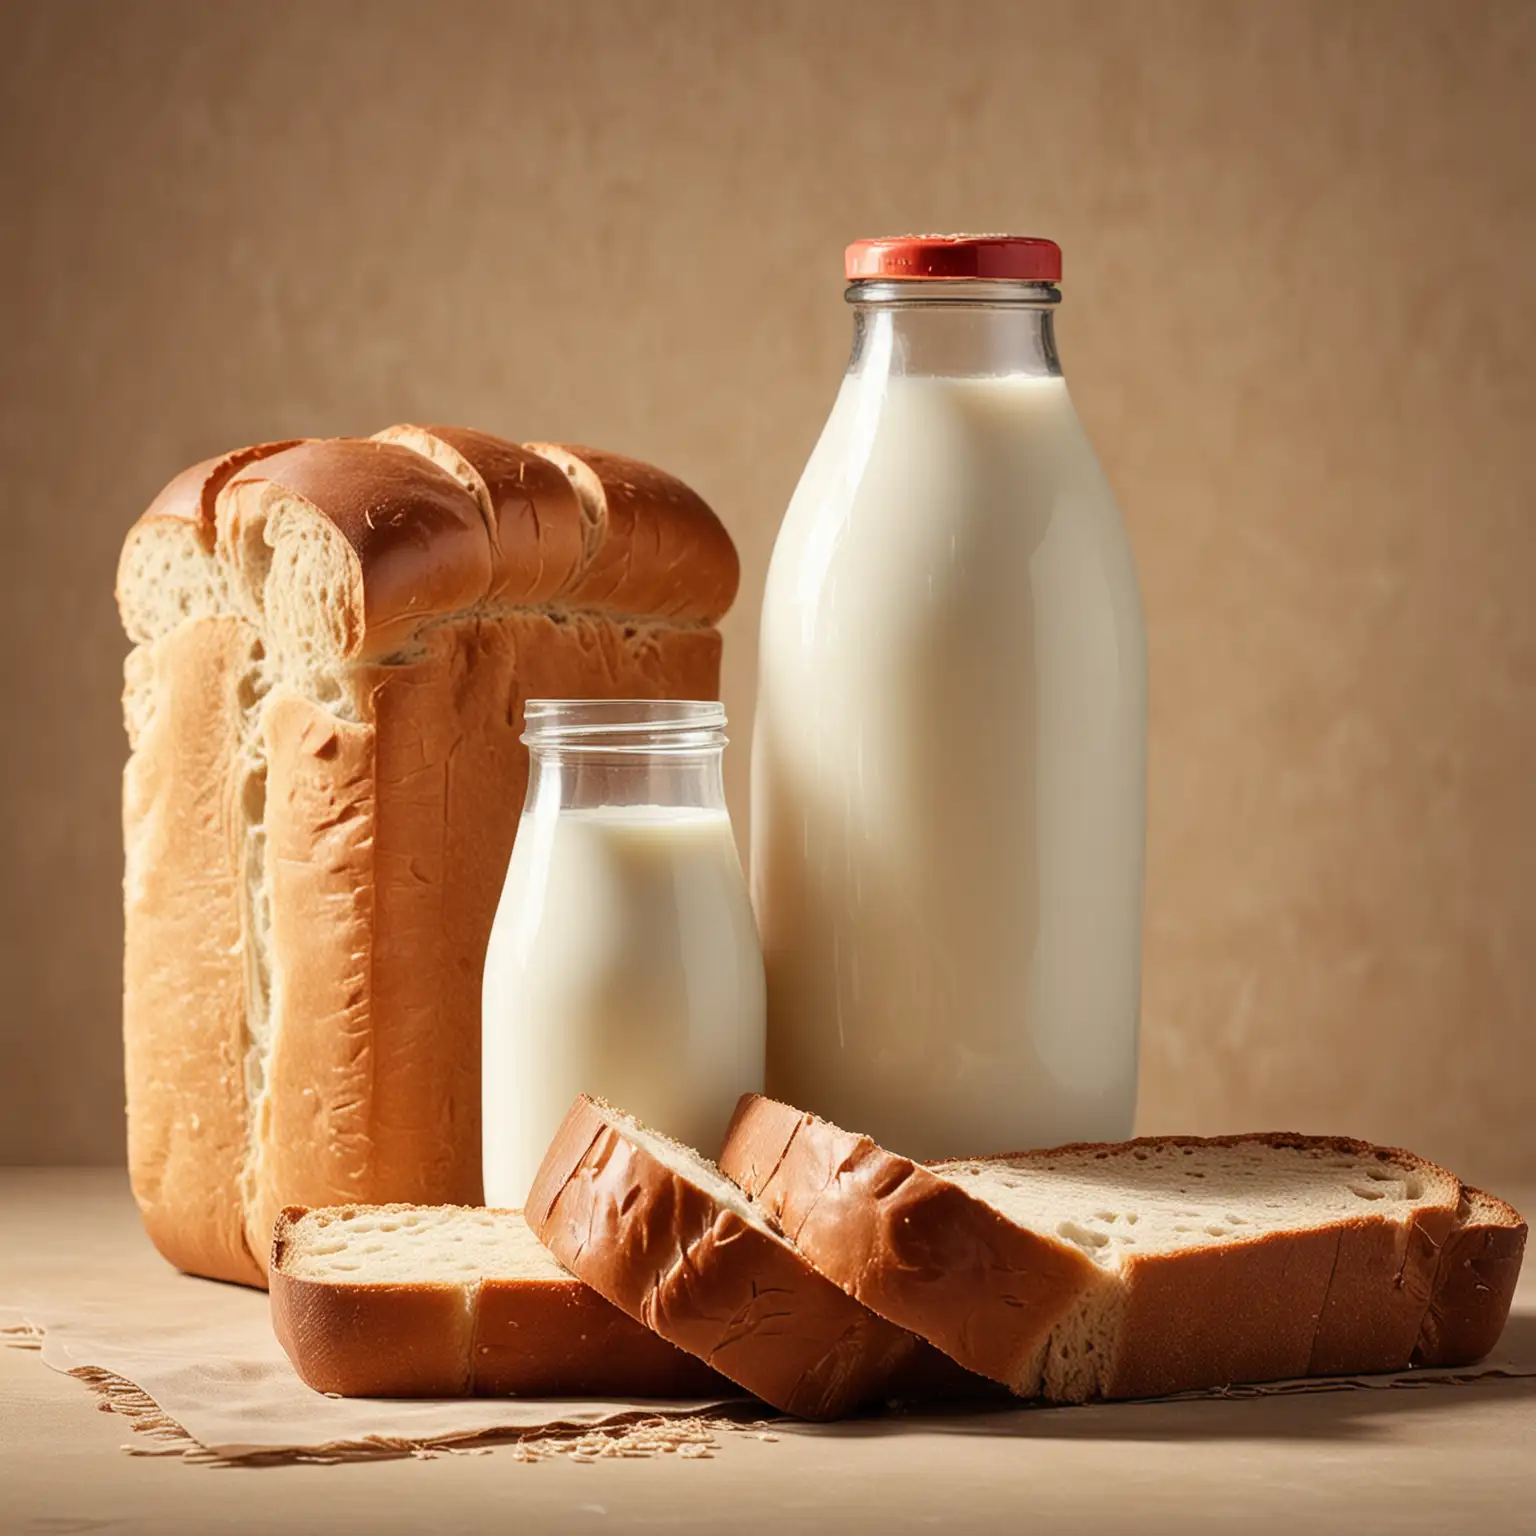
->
[{"left": 117, "top": 427, "right": 737, "bottom": 1284}]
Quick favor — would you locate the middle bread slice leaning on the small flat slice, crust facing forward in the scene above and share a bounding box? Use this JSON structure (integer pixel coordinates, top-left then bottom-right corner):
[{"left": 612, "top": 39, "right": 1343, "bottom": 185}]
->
[{"left": 527, "top": 1095, "right": 919, "bottom": 1419}]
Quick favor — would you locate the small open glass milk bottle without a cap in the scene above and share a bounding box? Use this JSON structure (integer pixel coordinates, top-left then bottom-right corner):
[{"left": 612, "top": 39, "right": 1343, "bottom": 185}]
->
[{"left": 481, "top": 699, "right": 763, "bottom": 1206}]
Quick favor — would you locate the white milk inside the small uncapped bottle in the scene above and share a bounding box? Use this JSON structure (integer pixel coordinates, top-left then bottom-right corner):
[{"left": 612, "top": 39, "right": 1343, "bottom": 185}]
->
[{"left": 482, "top": 805, "right": 763, "bottom": 1206}]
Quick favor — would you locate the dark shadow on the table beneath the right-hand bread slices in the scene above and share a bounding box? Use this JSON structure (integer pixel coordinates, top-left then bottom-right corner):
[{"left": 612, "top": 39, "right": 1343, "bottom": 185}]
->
[{"left": 792, "top": 1315, "right": 1536, "bottom": 1441}]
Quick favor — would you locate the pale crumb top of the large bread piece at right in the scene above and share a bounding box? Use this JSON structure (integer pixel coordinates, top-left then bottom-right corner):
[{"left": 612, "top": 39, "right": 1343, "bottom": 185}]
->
[{"left": 934, "top": 1141, "right": 1456, "bottom": 1269}]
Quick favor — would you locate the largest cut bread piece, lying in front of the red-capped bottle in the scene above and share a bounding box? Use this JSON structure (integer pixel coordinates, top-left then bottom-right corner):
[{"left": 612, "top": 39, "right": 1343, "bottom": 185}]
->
[{"left": 720, "top": 1095, "right": 1524, "bottom": 1401}]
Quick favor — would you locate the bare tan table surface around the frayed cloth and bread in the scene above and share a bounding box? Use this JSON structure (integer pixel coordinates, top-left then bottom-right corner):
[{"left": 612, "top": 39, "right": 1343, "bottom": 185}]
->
[{"left": 0, "top": 1169, "right": 1536, "bottom": 1536}]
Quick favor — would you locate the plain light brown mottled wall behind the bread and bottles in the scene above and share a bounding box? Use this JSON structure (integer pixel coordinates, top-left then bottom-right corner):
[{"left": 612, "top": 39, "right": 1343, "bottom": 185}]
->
[{"left": 0, "top": 0, "right": 1536, "bottom": 1181}]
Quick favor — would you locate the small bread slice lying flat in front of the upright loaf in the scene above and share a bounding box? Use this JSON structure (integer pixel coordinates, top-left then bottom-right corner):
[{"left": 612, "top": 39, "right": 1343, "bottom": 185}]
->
[{"left": 270, "top": 1206, "right": 734, "bottom": 1399}]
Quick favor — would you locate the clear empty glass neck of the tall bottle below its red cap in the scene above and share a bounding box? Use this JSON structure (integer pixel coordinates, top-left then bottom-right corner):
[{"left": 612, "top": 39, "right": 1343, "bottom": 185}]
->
[{"left": 846, "top": 281, "right": 1061, "bottom": 378}]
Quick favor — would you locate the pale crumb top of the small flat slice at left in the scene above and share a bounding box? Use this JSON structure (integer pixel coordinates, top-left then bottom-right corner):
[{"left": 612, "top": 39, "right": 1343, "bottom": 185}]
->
[{"left": 283, "top": 1206, "right": 578, "bottom": 1286}]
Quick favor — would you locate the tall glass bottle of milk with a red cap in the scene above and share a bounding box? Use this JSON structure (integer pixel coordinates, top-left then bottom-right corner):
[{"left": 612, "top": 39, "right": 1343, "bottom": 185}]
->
[{"left": 753, "top": 237, "right": 1146, "bottom": 1158}]
